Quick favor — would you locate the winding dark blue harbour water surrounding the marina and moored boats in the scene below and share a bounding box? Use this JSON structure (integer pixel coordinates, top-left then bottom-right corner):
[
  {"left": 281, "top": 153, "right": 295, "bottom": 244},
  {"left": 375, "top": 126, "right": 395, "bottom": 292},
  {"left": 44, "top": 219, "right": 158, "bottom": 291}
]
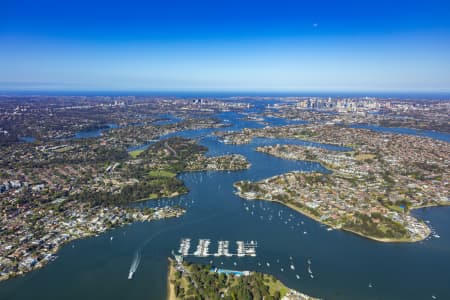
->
[{"left": 0, "top": 113, "right": 450, "bottom": 300}]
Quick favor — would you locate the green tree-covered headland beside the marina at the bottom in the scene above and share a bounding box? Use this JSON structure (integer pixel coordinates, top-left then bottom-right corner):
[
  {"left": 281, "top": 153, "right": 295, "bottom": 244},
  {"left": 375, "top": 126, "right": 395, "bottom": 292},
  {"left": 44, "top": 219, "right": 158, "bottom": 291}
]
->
[{"left": 167, "top": 257, "right": 317, "bottom": 300}]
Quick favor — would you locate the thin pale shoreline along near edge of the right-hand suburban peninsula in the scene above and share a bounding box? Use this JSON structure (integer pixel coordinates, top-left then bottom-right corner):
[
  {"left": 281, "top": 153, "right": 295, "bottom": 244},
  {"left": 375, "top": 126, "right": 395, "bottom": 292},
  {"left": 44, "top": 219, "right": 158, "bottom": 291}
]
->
[{"left": 233, "top": 184, "right": 442, "bottom": 243}]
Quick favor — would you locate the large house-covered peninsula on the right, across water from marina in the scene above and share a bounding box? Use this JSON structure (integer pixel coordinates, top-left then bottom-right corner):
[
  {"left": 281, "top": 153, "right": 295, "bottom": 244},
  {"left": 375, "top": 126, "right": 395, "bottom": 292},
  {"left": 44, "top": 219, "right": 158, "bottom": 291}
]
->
[{"left": 235, "top": 125, "right": 450, "bottom": 242}]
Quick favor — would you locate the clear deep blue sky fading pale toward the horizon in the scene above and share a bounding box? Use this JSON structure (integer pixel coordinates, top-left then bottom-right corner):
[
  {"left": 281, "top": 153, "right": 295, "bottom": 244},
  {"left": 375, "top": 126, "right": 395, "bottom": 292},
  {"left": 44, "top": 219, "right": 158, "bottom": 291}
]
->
[{"left": 0, "top": 0, "right": 450, "bottom": 92}]
